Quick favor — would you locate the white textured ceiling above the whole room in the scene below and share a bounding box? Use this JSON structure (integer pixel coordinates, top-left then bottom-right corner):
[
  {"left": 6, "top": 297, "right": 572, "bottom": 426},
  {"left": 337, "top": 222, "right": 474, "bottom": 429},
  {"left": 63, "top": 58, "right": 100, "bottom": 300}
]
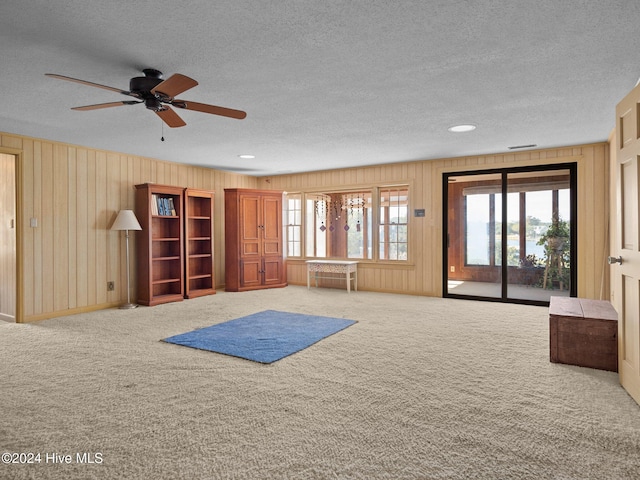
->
[{"left": 0, "top": 0, "right": 640, "bottom": 175}]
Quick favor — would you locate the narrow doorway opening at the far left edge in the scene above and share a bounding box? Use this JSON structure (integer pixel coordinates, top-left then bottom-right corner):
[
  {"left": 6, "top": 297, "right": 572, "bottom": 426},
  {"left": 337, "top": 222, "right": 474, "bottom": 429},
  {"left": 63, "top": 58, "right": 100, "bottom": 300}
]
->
[{"left": 0, "top": 153, "right": 18, "bottom": 322}]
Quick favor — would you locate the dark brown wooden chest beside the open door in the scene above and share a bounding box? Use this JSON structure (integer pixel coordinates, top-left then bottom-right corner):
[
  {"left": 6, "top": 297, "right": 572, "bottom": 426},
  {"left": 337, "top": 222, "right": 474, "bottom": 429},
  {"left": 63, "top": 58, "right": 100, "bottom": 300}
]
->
[{"left": 549, "top": 297, "right": 618, "bottom": 372}]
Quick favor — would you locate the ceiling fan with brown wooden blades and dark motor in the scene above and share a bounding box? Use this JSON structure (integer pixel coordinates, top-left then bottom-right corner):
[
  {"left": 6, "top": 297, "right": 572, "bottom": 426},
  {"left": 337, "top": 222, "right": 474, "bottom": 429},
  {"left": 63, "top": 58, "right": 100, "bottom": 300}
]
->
[{"left": 45, "top": 68, "right": 247, "bottom": 127}]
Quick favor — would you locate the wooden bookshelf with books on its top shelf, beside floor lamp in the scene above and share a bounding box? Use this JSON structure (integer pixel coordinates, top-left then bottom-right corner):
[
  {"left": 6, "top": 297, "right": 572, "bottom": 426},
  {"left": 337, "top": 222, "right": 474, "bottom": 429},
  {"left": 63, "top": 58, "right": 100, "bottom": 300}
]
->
[{"left": 136, "top": 183, "right": 184, "bottom": 306}]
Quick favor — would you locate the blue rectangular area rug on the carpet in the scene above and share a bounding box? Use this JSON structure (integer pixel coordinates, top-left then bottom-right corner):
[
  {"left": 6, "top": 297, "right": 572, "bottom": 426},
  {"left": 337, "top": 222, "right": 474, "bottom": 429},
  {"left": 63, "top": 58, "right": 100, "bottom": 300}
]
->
[{"left": 164, "top": 310, "right": 356, "bottom": 363}]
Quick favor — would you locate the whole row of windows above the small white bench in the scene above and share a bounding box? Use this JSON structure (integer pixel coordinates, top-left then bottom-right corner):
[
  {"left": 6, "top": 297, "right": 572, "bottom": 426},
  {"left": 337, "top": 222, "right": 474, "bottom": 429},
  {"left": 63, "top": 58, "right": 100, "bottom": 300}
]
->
[{"left": 287, "top": 185, "right": 409, "bottom": 261}]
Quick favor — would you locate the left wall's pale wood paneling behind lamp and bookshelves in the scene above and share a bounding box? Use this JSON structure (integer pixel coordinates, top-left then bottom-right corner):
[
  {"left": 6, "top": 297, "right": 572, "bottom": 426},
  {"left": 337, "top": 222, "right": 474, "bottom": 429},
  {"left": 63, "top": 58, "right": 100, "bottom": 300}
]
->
[{"left": 0, "top": 133, "right": 257, "bottom": 321}]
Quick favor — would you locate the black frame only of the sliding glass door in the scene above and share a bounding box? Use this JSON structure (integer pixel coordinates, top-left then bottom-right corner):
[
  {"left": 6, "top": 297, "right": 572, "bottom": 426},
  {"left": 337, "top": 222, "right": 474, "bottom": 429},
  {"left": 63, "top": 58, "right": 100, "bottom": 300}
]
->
[{"left": 442, "top": 162, "right": 579, "bottom": 306}]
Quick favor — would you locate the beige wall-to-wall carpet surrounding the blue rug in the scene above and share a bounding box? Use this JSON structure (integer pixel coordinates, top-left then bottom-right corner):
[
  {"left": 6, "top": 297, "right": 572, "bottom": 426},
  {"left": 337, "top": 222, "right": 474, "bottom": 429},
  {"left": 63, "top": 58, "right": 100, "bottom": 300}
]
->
[{"left": 0, "top": 287, "right": 640, "bottom": 480}]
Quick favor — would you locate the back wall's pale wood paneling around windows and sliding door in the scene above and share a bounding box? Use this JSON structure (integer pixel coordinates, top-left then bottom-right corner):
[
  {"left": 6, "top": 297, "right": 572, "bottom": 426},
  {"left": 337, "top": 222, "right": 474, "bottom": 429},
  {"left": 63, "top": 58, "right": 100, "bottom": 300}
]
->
[{"left": 258, "top": 142, "right": 609, "bottom": 299}]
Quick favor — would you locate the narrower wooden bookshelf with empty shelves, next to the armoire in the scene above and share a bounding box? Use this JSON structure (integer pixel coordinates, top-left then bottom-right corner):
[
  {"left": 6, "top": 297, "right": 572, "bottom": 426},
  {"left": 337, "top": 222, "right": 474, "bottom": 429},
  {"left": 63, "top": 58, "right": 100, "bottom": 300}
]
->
[{"left": 184, "top": 188, "right": 216, "bottom": 298}]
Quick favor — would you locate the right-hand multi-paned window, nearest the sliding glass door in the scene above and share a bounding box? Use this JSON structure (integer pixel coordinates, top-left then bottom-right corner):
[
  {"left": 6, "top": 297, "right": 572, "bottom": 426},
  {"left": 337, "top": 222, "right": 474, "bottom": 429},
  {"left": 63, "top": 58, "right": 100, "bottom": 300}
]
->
[{"left": 379, "top": 187, "right": 409, "bottom": 260}]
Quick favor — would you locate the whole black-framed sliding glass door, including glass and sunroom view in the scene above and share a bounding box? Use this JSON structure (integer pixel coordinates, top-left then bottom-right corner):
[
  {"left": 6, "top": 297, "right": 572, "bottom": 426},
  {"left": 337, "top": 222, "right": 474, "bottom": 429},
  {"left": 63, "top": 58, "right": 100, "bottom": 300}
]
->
[{"left": 443, "top": 164, "right": 577, "bottom": 305}]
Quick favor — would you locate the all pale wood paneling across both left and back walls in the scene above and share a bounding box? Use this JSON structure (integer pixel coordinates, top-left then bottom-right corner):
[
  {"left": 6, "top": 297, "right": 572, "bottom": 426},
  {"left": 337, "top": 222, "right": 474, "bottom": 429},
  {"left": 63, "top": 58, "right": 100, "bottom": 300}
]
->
[{"left": 0, "top": 129, "right": 609, "bottom": 321}]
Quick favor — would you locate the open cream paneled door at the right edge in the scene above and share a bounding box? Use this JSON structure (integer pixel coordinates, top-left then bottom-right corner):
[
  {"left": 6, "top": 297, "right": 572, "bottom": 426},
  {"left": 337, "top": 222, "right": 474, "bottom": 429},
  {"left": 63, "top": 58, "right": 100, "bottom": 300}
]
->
[{"left": 609, "top": 85, "right": 640, "bottom": 403}]
